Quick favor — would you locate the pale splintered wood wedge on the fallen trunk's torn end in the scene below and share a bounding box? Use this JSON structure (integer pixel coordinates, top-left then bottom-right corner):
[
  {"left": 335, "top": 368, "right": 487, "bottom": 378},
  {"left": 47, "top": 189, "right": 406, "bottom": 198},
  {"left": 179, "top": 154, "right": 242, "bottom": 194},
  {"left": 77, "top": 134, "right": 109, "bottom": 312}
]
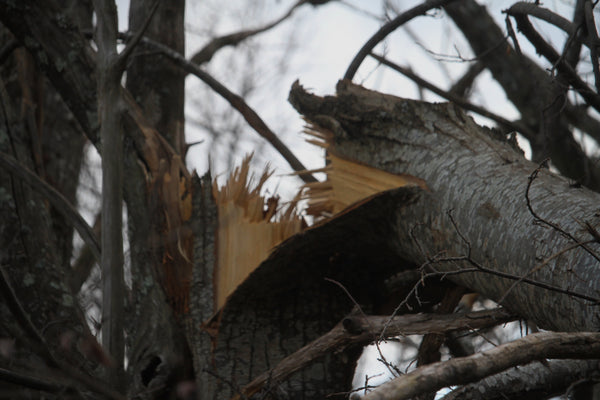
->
[{"left": 303, "top": 125, "right": 427, "bottom": 218}]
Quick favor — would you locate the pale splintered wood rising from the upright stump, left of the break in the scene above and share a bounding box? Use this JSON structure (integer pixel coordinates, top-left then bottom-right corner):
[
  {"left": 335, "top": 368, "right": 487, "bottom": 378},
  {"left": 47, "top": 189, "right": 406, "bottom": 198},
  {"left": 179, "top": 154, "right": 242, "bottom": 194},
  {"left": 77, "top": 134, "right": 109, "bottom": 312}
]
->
[{"left": 213, "top": 156, "right": 303, "bottom": 309}]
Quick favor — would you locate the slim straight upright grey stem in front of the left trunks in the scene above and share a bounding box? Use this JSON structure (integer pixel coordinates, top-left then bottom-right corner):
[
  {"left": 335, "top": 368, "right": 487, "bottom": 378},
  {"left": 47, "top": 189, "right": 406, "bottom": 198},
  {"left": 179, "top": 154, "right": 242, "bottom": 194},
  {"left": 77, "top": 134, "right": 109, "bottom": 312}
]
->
[{"left": 94, "top": 0, "right": 125, "bottom": 390}]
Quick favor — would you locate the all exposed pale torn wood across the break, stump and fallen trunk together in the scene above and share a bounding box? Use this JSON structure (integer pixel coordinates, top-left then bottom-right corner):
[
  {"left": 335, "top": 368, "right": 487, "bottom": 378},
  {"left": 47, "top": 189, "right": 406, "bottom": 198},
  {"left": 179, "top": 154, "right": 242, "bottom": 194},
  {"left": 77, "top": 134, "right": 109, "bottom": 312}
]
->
[{"left": 213, "top": 125, "right": 426, "bottom": 311}]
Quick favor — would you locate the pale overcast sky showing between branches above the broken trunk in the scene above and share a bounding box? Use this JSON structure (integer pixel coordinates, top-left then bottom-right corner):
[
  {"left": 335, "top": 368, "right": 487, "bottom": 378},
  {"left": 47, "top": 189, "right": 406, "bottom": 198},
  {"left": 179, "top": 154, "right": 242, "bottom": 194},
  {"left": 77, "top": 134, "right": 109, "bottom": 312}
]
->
[{"left": 110, "top": 0, "right": 571, "bottom": 203}]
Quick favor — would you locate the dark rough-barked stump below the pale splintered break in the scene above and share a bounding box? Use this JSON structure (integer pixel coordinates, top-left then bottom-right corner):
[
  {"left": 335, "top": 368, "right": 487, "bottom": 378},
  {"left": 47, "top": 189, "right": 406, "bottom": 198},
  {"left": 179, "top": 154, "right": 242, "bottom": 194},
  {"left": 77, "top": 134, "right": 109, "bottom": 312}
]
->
[{"left": 186, "top": 173, "right": 380, "bottom": 399}]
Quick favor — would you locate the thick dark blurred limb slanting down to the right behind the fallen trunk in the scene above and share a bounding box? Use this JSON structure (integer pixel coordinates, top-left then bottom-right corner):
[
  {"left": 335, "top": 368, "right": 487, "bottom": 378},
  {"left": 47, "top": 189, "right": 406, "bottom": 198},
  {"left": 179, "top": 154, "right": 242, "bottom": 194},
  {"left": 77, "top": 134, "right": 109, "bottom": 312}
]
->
[{"left": 444, "top": 0, "right": 600, "bottom": 190}]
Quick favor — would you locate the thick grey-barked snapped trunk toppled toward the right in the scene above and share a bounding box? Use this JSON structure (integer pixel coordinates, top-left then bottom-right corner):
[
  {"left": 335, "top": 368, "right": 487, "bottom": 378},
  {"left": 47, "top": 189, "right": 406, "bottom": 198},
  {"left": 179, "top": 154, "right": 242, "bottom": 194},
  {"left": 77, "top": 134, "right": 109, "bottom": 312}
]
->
[{"left": 290, "top": 81, "right": 600, "bottom": 331}]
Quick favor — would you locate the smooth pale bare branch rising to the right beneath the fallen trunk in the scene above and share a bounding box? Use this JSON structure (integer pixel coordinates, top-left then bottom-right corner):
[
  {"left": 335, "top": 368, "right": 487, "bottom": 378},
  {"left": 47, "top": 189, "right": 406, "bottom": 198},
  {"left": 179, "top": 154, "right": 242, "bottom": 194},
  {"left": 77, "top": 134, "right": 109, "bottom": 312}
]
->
[{"left": 364, "top": 332, "right": 600, "bottom": 400}]
